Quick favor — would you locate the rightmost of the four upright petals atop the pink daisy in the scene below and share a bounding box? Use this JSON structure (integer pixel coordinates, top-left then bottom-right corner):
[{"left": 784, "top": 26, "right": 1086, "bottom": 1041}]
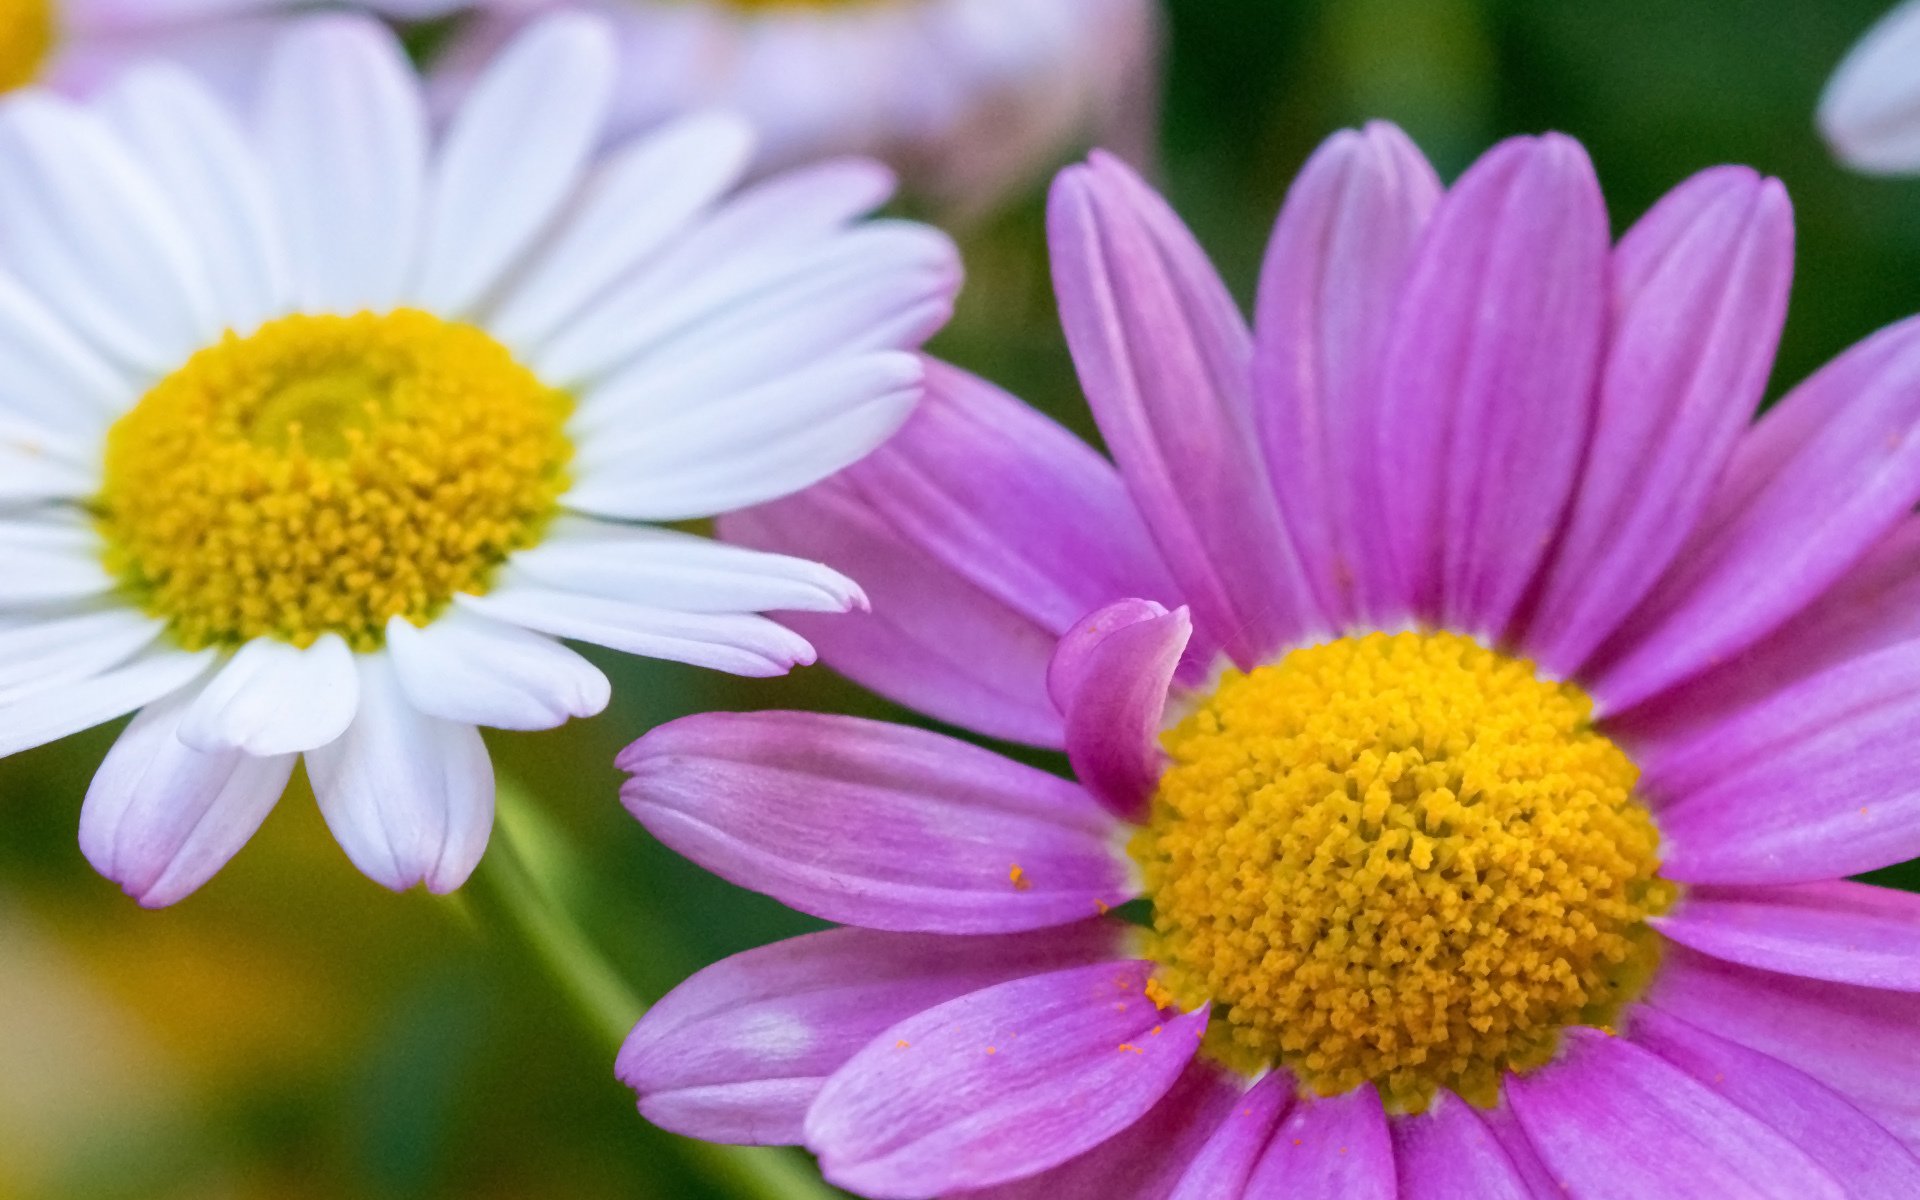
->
[{"left": 1526, "top": 167, "right": 1793, "bottom": 676}]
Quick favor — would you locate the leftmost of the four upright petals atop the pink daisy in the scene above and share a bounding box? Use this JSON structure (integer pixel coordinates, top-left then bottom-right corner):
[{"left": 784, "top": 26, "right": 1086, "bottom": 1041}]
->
[{"left": 1048, "top": 156, "right": 1323, "bottom": 666}]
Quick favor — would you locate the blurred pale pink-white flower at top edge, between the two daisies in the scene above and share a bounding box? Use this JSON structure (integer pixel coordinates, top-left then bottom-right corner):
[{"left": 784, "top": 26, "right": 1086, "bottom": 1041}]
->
[{"left": 440, "top": 0, "right": 1160, "bottom": 207}]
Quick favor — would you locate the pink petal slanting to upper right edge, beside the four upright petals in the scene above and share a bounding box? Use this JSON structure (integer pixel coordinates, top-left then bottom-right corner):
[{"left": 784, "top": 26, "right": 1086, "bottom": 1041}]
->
[{"left": 1590, "top": 312, "right": 1920, "bottom": 712}]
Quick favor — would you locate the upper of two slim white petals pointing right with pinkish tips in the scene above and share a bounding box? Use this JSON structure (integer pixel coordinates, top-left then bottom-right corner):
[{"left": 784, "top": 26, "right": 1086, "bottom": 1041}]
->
[{"left": 513, "top": 516, "right": 866, "bottom": 612}]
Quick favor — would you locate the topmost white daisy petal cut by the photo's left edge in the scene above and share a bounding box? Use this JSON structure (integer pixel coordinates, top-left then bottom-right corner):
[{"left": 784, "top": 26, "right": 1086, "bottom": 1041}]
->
[{"left": 0, "top": 92, "right": 219, "bottom": 371}]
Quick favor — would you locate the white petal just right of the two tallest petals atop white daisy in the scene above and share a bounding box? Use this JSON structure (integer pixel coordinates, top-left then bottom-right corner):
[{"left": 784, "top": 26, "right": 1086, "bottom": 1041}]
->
[{"left": 488, "top": 113, "right": 753, "bottom": 348}]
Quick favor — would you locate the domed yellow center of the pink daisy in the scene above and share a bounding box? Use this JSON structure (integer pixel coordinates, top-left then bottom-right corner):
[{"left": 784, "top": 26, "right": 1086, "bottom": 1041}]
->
[{"left": 1133, "top": 634, "right": 1674, "bottom": 1112}]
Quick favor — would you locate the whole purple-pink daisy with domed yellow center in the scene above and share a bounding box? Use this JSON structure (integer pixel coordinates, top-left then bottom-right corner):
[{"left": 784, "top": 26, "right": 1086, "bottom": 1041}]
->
[{"left": 620, "top": 125, "right": 1920, "bottom": 1200}]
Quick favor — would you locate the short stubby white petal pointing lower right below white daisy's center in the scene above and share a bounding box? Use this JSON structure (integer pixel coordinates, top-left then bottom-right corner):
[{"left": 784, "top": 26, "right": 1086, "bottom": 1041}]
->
[{"left": 386, "top": 609, "right": 612, "bottom": 730}]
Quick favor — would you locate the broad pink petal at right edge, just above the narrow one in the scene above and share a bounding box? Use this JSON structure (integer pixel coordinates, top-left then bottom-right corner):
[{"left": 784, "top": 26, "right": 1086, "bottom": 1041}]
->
[{"left": 1640, "top": 641, "right": 1920, "bottom": 883}]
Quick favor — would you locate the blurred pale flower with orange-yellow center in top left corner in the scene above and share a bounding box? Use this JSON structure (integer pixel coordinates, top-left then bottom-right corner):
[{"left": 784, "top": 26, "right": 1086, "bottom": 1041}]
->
[{"left": 0, "top": 0, "right": 463, "bottom": 94}]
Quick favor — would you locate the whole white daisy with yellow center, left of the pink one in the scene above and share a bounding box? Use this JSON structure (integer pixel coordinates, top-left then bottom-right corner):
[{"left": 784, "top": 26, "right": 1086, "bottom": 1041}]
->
[{"left": 0, "top": 15, "right": 958, "bottom": 904}]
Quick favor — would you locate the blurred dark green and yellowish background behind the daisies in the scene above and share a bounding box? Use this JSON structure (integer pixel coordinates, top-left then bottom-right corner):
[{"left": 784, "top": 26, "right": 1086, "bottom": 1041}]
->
[{"left": 0, "top": 0, "right": 1920, "bottom": 1200}]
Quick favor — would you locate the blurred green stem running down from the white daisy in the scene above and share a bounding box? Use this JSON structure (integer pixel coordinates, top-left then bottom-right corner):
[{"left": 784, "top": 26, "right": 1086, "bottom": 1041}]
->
[{"left": 474, "top": 780, "right": 841, "bottom": 1200}]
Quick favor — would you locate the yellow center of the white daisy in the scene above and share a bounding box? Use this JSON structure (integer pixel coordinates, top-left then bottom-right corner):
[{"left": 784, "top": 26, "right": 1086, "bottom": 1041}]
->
[{"left": 96, "top": 309, "right": 572, "bottom": 649}]
